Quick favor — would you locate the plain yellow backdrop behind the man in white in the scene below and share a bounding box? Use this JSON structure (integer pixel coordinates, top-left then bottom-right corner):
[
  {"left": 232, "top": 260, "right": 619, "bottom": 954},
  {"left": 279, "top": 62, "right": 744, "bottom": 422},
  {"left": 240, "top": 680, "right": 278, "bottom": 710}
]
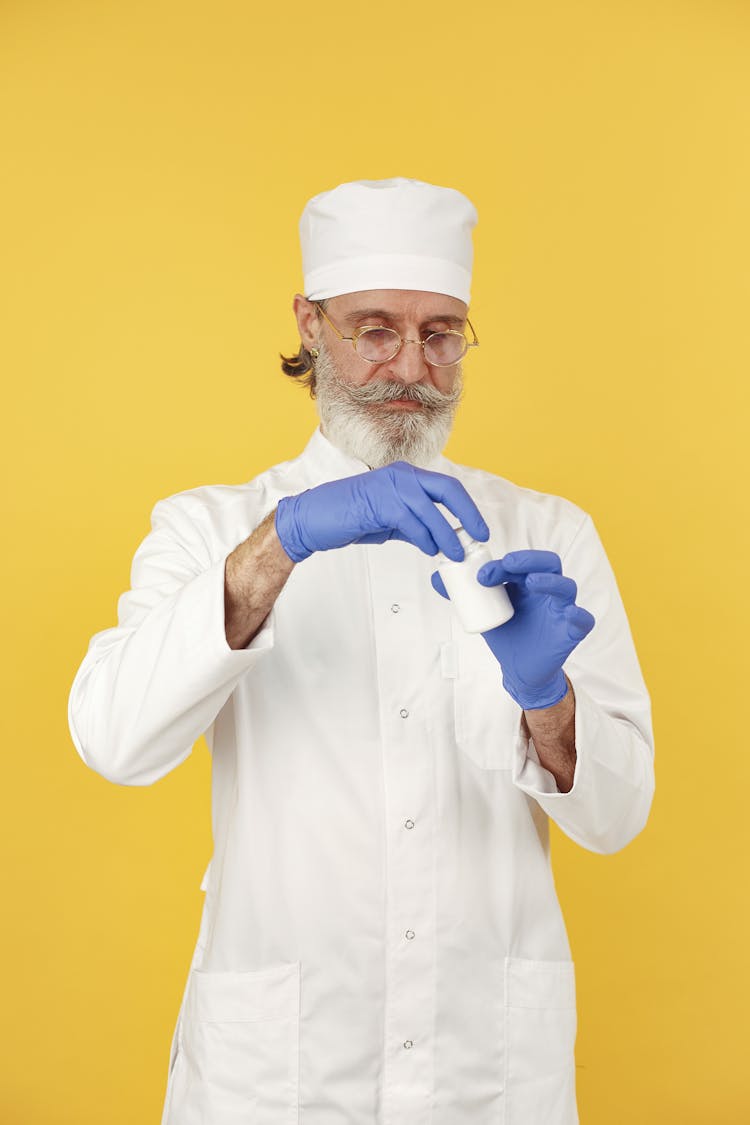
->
[{"left": 0, "top": 0, "right": 750, "bottom": 1125}]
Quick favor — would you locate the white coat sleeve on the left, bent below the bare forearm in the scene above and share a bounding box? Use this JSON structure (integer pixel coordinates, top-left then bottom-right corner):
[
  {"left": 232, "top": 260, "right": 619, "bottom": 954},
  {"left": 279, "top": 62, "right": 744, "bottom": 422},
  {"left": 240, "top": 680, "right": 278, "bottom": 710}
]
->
[{"left": 67, "top": 494, "right": 274, "bottom": 785}]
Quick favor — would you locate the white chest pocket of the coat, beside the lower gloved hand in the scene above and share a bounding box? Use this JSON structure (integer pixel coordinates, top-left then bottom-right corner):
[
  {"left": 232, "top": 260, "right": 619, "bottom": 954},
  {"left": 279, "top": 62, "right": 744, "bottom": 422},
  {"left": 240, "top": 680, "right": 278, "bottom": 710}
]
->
[{"left": 443, "top": 623, "right": 521, "bottom": 770}]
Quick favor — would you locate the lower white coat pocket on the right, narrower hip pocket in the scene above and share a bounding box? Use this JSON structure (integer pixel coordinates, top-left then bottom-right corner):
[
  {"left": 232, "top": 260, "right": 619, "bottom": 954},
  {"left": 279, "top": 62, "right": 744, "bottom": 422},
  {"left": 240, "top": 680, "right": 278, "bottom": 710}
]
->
[{"left": 505, "top": 957, "right": 578, "bottom": 1125}]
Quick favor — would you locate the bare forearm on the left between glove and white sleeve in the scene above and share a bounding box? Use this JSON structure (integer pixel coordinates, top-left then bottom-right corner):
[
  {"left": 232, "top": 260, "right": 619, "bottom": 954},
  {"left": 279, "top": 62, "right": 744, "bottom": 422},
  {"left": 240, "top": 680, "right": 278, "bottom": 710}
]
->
[{"left": 224, "top": 509, "right": 296, "bottom": 649}]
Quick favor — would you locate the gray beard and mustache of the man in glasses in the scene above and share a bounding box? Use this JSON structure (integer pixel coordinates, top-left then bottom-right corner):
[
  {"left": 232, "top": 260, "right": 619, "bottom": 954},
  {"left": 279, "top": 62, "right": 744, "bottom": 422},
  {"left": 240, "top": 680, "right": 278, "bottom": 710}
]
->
[{"left": 315, "top": 343, "right": 463, "bottom": 469}]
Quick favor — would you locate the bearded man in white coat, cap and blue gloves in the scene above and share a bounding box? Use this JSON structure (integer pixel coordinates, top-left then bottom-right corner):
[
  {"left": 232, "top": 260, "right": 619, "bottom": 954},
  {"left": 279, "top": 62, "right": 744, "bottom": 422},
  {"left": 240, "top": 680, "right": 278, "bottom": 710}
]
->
[{"left": 69, "top": 178, "right": 654, "bottom": 1125}]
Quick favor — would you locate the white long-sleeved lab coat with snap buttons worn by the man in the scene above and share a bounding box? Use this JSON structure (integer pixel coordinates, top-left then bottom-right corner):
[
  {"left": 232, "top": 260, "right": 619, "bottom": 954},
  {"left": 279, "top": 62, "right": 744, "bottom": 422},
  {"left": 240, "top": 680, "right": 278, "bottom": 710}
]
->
[{"left": 69, "top": 429, "right": 654, "bottom": 1125}]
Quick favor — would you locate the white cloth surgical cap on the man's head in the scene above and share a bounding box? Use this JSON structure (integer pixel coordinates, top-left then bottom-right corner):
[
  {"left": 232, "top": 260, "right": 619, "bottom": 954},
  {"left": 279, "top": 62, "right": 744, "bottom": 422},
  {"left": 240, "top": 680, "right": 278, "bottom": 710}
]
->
[{"left": 299, "top": 177, "right": 477, "bottom": 305}]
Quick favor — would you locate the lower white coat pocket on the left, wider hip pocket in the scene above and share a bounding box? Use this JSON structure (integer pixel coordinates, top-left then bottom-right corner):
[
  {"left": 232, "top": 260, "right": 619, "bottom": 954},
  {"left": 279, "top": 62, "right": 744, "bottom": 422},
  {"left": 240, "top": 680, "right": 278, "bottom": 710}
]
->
[{"left": 172, "top": 961, "right": 300, "bottom": 1125}]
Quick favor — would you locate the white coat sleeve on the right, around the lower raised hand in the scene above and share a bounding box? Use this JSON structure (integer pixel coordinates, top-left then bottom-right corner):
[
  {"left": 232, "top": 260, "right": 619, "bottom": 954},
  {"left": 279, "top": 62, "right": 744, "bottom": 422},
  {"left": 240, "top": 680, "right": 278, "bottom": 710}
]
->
[{"left": 512, "top": 514, "right": 654, "bottom": 854}]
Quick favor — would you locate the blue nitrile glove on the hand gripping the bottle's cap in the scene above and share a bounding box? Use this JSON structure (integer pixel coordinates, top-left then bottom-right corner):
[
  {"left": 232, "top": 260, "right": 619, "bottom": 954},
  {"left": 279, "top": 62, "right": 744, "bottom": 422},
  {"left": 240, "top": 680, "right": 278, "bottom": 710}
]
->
[{"left": 275, "top": 461, "right": 489, "bottom": 563}]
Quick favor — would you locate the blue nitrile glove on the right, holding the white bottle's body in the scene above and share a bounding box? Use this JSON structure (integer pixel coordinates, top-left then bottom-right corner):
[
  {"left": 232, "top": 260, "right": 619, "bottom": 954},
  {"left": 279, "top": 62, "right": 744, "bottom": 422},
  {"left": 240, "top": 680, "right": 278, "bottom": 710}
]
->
[{"left": 432, "top": 550, "right": 594, "bottom": 711}]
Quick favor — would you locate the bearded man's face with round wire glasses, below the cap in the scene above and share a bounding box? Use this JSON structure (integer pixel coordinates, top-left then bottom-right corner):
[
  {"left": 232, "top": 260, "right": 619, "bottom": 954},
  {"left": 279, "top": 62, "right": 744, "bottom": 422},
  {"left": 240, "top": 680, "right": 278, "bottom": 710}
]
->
[{"left": 295, "top": 289, "right": 467, "bottom": 468}]
